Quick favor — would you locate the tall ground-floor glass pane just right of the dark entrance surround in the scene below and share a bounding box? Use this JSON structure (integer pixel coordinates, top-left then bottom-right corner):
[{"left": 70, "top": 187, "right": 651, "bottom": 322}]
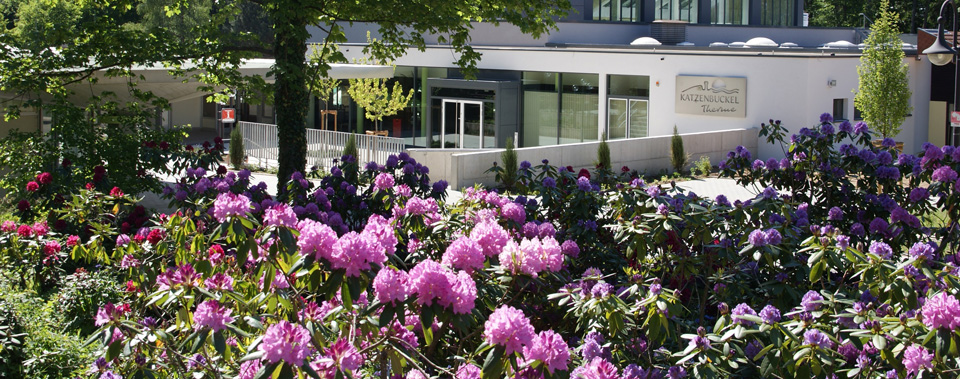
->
[{"left": 521, "top": 72, "right": 560, "bottom": 147}]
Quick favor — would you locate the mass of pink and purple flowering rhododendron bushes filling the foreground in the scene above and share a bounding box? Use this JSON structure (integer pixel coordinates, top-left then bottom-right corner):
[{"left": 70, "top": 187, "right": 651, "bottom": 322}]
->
[{"left": 0, "top": 113, "right": 960, "bottom": 379}]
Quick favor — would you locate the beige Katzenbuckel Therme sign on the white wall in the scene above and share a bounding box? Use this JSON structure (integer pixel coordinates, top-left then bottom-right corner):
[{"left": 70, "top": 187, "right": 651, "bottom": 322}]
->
[{"left": 677, "top": 75, "right": 747, "bottom": 118}]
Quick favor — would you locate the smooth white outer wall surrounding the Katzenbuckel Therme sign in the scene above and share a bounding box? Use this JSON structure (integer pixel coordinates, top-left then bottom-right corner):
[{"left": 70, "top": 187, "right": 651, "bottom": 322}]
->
[{"left": 350, "top": 46, "right": 929, "bottom": 158}]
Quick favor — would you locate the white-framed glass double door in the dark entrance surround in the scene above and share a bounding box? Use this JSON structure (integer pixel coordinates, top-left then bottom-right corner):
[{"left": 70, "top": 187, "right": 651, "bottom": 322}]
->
[{"left": 440, "top": 99, "right": 493, "bottom": 149}]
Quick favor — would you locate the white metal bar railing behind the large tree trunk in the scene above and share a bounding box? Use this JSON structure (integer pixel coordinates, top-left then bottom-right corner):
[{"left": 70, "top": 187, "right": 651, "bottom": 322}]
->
[{"left": 237, "top": 122, "right": 405, "bottom": 168}]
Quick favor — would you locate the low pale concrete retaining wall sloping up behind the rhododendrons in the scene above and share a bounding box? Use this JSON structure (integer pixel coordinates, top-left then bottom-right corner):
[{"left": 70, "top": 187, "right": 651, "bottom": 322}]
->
[{"left": 407, "top": 128, "right": 759, "bottom": 189}]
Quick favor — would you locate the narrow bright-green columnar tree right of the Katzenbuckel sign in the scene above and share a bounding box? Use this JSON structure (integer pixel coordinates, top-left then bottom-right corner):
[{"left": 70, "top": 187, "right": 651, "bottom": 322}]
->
[{"left": 853, "top": 0, "right": 911, "bottom": 137}]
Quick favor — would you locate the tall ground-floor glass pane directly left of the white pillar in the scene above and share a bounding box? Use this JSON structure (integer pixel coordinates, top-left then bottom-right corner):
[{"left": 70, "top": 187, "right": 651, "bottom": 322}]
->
[{"left": 560, "top": 74, "right": 600, "bottom": 144}]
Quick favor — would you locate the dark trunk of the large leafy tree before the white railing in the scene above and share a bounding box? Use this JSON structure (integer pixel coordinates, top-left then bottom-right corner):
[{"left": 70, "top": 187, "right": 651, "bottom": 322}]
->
[{"left": 274, "top": 8, "right": 310, "bottom": 193}]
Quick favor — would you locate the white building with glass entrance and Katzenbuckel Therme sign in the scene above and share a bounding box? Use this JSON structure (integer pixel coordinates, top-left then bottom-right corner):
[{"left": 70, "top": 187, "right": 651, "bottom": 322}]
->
[{"left": 313, "top": 0, "right": 930, "bottom": 157}]
